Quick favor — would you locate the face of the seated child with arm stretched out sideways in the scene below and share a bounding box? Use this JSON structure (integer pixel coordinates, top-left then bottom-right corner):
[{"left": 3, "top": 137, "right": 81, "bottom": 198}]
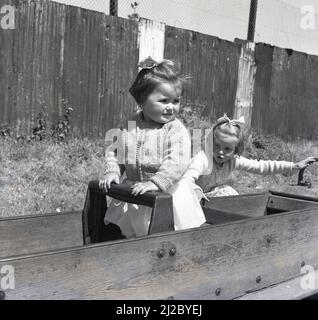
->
[{"left": 213, "top": 130, "right": 238, "bottom": 164}]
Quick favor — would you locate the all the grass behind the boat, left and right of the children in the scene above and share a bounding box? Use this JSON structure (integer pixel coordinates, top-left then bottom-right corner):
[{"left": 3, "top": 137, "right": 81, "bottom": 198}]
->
[{"left": 0, "top": 130, "right": 318, "bottom": 217}]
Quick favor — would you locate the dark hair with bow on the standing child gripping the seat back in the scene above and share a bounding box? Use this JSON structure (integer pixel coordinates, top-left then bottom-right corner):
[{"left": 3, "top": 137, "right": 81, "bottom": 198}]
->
[{"left": 129, "top": 57, "right": 187, "bottom": 104}]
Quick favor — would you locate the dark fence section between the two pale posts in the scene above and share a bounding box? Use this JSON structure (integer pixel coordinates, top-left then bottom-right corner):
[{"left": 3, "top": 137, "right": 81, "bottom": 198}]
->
[{"left": 164, "top": 26, "right": 241, "bottom": 119}]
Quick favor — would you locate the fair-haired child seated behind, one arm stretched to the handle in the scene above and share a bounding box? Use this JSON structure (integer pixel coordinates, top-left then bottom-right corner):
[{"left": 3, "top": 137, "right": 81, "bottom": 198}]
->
[{"left": 183, "top": 114, "right": 315, "bottom": 200}]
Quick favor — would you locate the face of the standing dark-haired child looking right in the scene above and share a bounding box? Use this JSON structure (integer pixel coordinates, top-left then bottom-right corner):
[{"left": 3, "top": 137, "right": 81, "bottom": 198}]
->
[{"left": 140, "top": 82, "right": 181, "bottom": 124}]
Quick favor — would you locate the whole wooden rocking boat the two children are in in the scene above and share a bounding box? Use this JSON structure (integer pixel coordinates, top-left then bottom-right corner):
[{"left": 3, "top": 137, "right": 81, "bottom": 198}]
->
[{"left": 0, "top": 168, "right": 318, "bottom": 300}]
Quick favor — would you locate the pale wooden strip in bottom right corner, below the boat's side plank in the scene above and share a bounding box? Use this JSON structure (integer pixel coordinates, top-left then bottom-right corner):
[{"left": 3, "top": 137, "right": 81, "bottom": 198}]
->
[{"left": 236, "top": 270, "right": 318, "bottom": 300}]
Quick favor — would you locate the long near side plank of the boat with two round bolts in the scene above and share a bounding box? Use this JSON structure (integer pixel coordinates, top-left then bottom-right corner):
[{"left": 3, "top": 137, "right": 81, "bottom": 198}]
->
[{"left": 0, "top": 209, "right": 318, "bottom": 299}]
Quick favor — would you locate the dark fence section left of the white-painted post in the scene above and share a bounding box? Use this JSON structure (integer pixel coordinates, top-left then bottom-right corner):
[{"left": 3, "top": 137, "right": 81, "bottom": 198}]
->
[{"left": 0, "top": 0, "right": 138, "bottom": 137}]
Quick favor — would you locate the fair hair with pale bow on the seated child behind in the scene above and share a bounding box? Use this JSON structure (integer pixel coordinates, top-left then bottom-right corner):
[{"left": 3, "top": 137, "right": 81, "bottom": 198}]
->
[{"left": 213, "top": 115, "right": 245, "bottom": 156}]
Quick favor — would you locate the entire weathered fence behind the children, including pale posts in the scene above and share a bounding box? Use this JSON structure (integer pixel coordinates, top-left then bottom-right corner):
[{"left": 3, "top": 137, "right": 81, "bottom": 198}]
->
[{"left": 0, "top": 0, "right": 318, "bottom": 138}]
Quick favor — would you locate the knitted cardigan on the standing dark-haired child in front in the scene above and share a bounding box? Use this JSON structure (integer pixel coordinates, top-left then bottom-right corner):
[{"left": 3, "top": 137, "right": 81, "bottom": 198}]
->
[{"left": 105, "top": 112, "right": 191, "bottom": 191}]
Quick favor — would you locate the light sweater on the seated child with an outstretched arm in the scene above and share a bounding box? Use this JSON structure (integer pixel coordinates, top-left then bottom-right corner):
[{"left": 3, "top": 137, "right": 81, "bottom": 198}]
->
[{"left": 183, "top": 151, "right": 294, "bottom": 192}]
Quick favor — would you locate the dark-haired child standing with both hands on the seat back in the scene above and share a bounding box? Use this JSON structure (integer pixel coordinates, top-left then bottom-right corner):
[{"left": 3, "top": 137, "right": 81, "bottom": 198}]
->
[{"left": 100, "top": 57, "right": 191, "bottom": 238}]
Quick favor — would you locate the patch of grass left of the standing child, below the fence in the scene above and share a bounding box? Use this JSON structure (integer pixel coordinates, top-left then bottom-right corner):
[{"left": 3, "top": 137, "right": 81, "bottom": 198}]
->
[{"left": 0, "top": 138, "right": 104, "bottom": 217}]
